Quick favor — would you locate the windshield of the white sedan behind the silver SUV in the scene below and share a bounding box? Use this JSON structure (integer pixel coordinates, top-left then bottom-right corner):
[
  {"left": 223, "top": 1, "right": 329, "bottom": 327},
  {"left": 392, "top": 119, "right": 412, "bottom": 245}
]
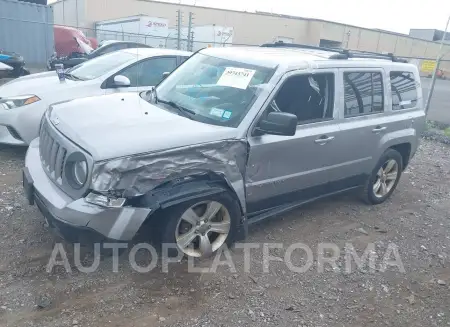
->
[{"left": 67, "top": 51, "right": 136, "bottom": 80}]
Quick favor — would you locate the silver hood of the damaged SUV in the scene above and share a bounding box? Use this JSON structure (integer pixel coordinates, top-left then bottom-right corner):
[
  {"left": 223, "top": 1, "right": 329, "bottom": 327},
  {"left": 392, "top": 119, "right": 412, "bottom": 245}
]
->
[{"left": 50, "top": 93, "right": 237, "bottom": 161}]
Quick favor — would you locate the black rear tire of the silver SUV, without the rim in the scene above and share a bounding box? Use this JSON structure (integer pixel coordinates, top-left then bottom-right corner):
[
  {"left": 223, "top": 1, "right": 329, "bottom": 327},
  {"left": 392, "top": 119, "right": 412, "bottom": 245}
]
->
[{"left": 362, "top": 149, "right": 403, "bottom": 205}]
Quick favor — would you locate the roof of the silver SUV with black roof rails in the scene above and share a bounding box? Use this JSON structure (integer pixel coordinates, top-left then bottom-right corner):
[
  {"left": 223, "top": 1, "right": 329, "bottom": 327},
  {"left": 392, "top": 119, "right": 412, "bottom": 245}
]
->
[{"left": 202, "top": 47, "right": 414, "bottom": 68}]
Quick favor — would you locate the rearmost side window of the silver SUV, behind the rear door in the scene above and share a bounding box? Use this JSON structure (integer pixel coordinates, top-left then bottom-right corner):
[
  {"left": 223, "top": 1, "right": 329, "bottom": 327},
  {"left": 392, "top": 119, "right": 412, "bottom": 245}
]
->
[{"left": 390, "top": 72, "right": 417, "bottom": 110}]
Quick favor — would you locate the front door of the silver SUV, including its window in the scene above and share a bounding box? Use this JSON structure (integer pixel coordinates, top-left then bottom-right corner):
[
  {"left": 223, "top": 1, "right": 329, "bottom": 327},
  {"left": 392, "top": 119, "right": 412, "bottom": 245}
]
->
[{"left": 245, "top": 69, "right": 339, "bottom": 216}]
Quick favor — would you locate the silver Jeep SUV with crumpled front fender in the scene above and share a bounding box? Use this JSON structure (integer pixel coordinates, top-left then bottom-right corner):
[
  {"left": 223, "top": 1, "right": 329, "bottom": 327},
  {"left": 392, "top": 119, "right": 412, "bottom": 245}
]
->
[{"left": 23, "top": 44, "right": 425, "bottom": 257}]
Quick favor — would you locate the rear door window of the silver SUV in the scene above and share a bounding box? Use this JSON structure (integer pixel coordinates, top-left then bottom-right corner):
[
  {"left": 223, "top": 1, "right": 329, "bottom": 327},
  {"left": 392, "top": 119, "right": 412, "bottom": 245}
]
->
[{"left": 344, "top": 72, "right": 384, "bottom": 118}]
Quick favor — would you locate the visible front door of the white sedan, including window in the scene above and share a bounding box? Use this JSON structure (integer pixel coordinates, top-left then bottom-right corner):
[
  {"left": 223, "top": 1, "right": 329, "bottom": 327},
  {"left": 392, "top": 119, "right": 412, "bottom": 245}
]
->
[{"left": 105, "top": 56, "right": 177, "bottom": 94}]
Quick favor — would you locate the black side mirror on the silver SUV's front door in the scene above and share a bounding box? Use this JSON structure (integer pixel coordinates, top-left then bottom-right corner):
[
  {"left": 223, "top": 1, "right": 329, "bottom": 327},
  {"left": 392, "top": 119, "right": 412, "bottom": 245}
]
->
[{"left": 257, "top": 111, "right": 297, "bottom": 136}]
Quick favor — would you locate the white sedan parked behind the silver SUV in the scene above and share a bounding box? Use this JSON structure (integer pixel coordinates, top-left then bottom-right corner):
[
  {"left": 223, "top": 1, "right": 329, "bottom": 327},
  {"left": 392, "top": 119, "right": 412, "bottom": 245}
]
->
[{"left": 0, "top": 48, "right": 191, "bottom": 146}]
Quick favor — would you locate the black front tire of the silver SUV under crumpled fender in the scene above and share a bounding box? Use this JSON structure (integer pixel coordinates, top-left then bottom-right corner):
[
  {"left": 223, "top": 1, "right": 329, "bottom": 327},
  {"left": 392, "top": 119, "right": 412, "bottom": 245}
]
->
[{"left": 149, "top": 190, "right": 242, "bottom": 259}]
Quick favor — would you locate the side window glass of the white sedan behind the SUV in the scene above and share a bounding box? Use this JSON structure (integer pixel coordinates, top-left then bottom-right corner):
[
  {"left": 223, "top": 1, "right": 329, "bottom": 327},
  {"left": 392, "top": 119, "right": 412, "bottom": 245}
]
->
[{"left": 119, "top": 57, "right": 177, "bottom": 87}]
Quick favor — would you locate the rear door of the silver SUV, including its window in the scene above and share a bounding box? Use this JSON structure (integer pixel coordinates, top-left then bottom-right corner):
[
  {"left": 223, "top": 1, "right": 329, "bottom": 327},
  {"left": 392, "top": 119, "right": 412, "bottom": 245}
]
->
[{"left": 330, "top": 68, "right": 389, "bottom": 189}]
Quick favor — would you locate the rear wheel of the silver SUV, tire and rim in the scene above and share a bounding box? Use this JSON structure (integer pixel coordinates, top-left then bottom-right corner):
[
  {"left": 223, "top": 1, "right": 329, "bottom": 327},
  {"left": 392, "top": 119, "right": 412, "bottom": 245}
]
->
[{"left": 362, "top": 149, "right": 403, "bottom": 204}]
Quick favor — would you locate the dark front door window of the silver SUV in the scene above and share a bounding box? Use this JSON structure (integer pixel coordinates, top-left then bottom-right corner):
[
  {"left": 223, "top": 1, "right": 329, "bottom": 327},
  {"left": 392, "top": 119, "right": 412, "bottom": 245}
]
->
[{"left": 267, "top": 73, "right": 334, "bottom": 125}]
